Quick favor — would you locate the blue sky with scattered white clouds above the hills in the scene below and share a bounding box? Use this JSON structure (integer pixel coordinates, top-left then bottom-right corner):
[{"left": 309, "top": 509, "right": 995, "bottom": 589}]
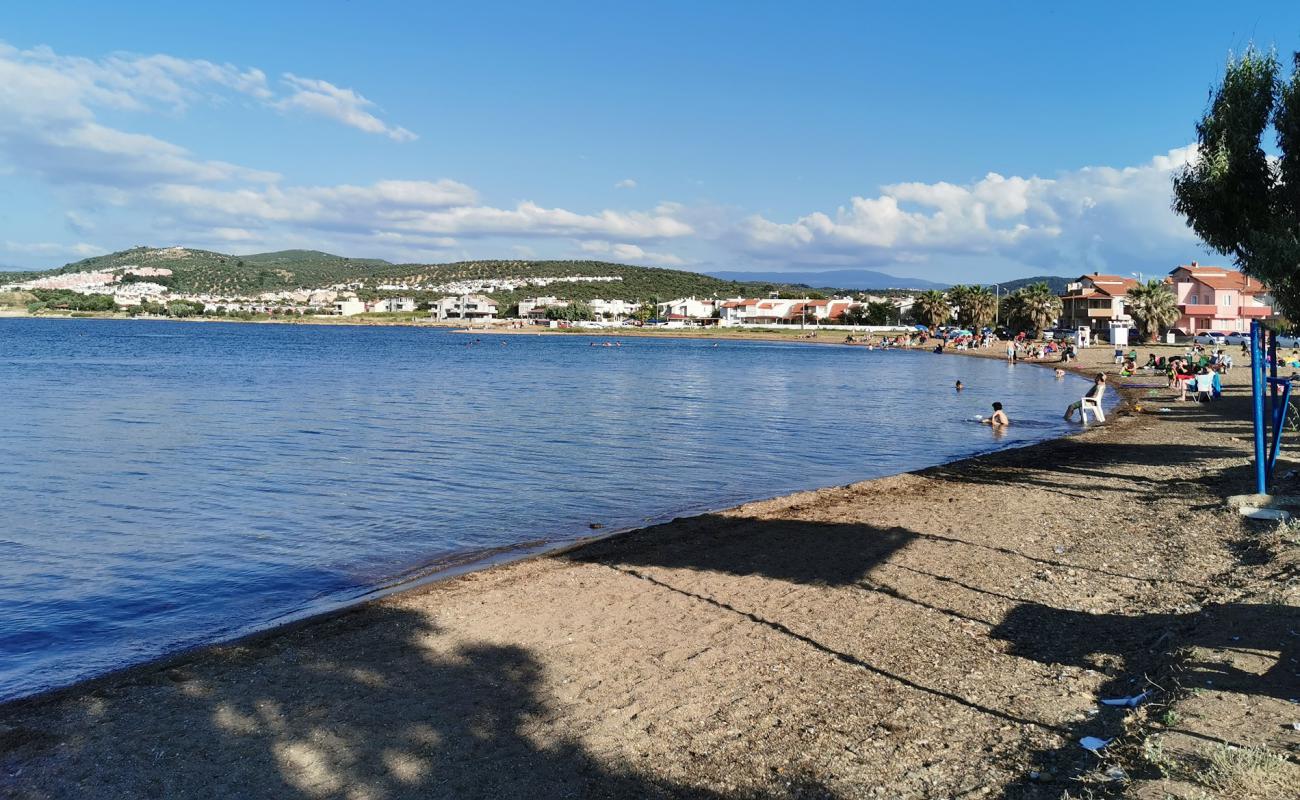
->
[{"left": 0, "top": 0, "right": 1300, "bottom": 281}]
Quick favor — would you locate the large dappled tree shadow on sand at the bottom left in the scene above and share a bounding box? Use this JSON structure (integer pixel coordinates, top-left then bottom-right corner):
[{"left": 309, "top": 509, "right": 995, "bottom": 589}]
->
[{"left": 0, "top": 606, "right": 832, "bottom": 800}]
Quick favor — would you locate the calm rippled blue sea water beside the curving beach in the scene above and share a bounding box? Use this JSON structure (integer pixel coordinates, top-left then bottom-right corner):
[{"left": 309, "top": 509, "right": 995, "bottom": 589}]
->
[{"left": 0, "top": 319, "right": 1102, "bottom": 700}]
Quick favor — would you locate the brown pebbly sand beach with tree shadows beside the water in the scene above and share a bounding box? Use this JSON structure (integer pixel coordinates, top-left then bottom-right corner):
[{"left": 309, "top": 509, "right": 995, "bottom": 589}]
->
[{"left": 0, "top": 347, "right": 1300, "bottom": 800}]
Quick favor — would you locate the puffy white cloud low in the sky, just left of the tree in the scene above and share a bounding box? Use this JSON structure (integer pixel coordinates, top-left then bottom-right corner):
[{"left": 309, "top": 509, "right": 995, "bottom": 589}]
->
[{"left": 738, "top": 147, "right": 1195, "bottom": 274}]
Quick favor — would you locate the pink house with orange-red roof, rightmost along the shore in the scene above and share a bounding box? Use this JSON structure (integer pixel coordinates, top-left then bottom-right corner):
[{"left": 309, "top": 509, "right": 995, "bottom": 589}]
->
[{"left": 1166, "top": 261, "right": 1273, "bottom": 334}]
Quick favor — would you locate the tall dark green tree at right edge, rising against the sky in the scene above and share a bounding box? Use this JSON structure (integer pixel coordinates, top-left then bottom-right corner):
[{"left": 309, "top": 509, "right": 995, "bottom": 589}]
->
[{"left": 1174, "top": 47, "right": 1300, "bottom": 317}]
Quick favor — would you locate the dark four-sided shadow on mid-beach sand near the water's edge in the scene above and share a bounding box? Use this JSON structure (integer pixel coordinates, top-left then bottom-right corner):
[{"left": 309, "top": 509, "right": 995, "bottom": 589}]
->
[{"left": 564, "top": 514, "right": 917, "bottom": 585}]
